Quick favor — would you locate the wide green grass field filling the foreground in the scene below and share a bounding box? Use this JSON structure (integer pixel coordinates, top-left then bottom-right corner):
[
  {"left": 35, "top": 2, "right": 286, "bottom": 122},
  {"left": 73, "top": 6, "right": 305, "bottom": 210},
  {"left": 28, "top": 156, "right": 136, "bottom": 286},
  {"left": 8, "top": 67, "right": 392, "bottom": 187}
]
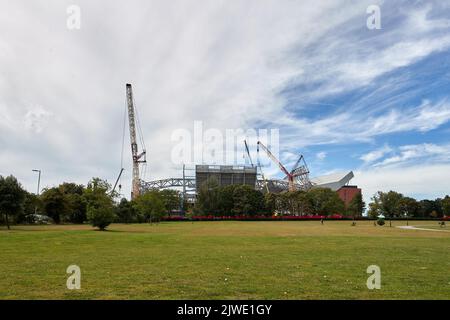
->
[{"left": 0, "top": 221, "right": 450, "bottom": 299}]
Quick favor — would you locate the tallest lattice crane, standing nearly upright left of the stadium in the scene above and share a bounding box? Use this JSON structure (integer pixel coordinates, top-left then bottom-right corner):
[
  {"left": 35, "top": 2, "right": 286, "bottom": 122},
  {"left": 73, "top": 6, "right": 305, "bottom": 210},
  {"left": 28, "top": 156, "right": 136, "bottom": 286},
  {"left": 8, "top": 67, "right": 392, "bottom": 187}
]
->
[{"left": 126, "top": 83, "right": 146, "bottom": 199}]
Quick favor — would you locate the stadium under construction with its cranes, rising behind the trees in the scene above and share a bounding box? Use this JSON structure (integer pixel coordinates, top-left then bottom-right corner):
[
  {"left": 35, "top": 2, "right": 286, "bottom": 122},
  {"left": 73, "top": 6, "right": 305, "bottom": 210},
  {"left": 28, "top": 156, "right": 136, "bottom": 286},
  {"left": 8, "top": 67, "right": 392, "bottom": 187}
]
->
[{"left": 119, "top": 84, "right": 361, "bottom": 205}]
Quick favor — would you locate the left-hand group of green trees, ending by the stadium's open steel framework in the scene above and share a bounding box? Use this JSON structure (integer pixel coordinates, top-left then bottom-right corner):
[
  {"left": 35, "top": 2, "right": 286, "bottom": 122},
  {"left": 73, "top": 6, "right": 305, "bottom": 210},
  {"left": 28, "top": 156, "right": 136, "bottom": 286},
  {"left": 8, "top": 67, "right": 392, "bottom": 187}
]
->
[{"left": 0, "top": 176, "right": 181, "bottom": 230}]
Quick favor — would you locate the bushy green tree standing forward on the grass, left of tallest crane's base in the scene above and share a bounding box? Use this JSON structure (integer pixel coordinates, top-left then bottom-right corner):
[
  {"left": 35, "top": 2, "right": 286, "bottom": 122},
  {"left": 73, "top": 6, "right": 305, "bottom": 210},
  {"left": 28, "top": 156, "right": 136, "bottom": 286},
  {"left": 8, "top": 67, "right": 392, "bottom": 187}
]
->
[{"left": 87, "top": 194, "right": 114, "bottom": 231}]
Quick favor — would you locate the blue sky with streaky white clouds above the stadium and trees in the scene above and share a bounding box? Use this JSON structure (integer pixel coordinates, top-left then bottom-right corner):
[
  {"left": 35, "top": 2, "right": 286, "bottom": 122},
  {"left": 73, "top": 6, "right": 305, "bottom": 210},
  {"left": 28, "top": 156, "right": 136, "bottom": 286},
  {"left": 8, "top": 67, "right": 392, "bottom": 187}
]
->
[{"left": 0, "top": 0, "right": 450, "bottom": 205}]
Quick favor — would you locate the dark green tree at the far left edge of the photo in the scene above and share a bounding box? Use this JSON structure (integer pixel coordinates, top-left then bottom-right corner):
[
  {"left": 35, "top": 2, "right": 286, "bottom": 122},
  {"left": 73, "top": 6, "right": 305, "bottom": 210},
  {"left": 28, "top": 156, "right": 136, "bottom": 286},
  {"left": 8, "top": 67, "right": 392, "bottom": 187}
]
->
[{"left": 0, "top": 175, "right": 25, "bottom": 230}]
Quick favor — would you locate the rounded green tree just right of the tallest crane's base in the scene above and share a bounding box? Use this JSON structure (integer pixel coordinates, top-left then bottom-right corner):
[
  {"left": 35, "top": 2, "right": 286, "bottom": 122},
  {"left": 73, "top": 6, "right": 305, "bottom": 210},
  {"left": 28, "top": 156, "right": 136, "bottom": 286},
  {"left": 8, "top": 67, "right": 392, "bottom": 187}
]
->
[{"left": 134, "top": 190, "right": 166, "bottom": 223}]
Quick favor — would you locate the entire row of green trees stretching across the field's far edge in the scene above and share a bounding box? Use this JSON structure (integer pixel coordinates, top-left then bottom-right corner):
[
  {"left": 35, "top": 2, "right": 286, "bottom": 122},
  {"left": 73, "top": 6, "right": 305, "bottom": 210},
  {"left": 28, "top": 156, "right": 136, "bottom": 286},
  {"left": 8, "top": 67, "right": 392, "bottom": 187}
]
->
[{"left": 0, "top": 172, "right": 450, "bottom": 230}]
